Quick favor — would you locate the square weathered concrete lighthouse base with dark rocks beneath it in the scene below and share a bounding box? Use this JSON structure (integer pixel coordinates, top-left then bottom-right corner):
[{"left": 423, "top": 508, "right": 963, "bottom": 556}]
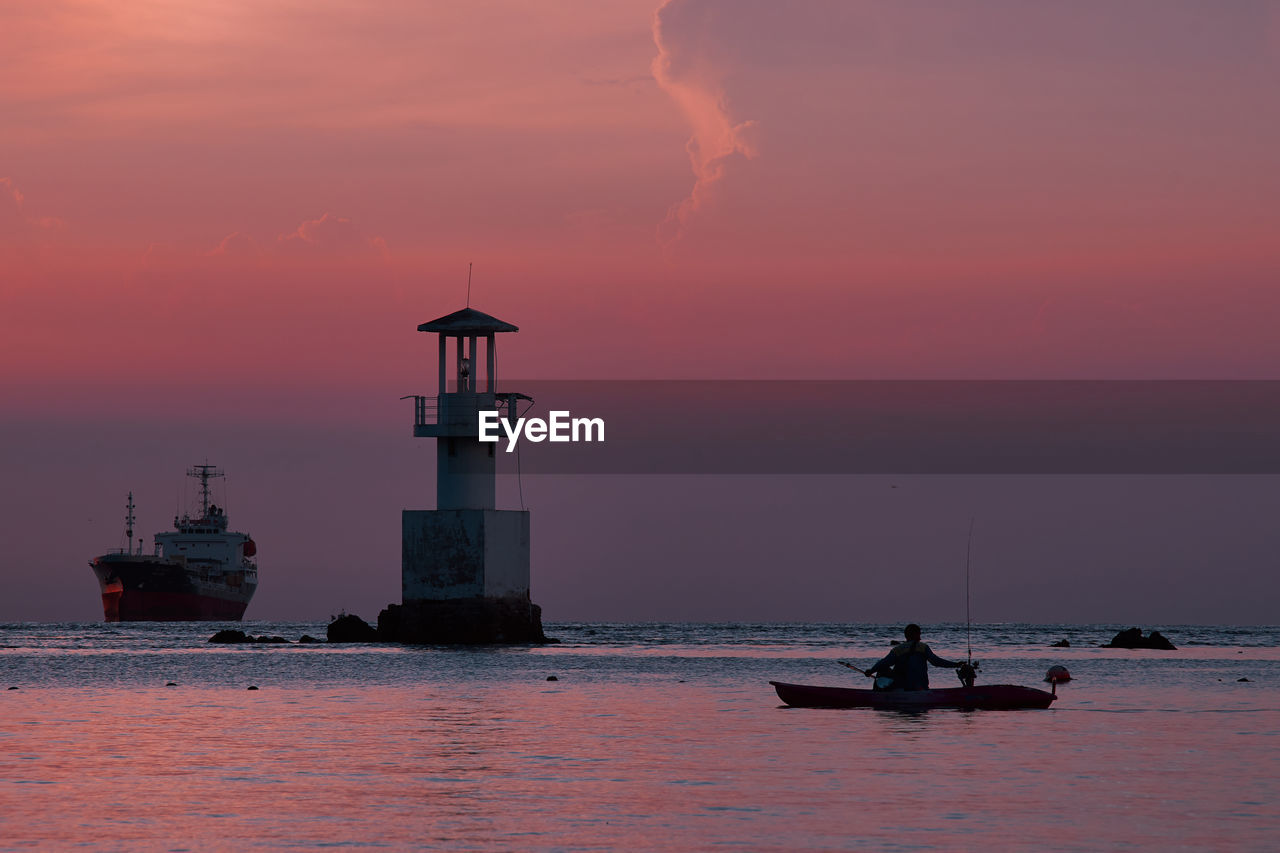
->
[{"left": 378, "top": 510, "right": 549, "bottom": 643}]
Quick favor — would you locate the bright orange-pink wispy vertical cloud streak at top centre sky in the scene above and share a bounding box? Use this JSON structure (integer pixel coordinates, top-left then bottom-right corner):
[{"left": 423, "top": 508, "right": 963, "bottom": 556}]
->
[{"left": 653, "top": 0, "right": 756, "bottom": 245}]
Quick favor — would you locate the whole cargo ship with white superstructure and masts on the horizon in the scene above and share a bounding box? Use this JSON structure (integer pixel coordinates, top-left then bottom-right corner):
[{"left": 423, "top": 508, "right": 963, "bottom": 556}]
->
[{"left": 90, "top": 465, "right": 257, "bottom": 622}]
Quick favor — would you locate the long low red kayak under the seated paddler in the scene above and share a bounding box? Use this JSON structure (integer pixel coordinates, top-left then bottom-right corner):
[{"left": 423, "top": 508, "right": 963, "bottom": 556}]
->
[{"left": 769, "top": 681, "right": 1057, "bottom": 711}]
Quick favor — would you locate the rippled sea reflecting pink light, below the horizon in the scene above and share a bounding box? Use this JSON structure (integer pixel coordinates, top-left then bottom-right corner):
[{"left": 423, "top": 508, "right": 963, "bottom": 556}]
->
[{"left": 0, "top": 622, "right": 1280, "bottom": 850}]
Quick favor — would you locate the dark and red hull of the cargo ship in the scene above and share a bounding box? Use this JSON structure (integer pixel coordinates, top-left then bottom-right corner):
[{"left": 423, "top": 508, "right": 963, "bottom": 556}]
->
[{"left": 91, "top": 555, "right": 257, "bottom": 622}]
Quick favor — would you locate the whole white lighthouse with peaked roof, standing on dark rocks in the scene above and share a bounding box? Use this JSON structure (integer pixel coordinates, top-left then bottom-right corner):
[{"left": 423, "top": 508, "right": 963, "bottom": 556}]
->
[{"left": 378, "top": 307, "right": 545, "bottom": 643}]
